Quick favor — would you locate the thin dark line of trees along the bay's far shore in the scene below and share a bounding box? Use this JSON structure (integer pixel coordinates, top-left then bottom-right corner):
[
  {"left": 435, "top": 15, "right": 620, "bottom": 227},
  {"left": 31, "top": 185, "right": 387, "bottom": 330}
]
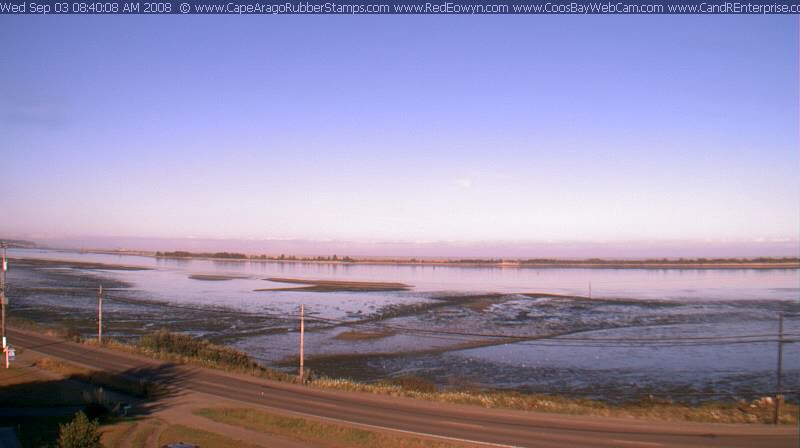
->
[{"left": 156, "top": 251, "right": 800, "bottom": 266}]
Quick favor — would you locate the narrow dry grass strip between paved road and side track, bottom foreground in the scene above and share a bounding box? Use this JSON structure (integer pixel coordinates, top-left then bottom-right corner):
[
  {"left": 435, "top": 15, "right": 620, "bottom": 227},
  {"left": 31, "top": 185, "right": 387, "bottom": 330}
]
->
[{"left": 194, "top": 408, "right": 476, "bottom": 448}]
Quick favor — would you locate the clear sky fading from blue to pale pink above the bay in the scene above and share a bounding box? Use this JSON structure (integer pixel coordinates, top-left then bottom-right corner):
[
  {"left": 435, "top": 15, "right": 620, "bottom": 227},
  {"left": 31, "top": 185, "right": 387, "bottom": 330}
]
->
[{"left": 0, "top": 16, "right": 800, "bottom": 256}]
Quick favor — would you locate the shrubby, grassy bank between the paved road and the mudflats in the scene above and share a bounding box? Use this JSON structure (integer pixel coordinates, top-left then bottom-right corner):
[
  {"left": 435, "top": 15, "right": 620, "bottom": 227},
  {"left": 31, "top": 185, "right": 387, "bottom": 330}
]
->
[{"left": 9, "top": 320, "right": 798, "bottom": 424}]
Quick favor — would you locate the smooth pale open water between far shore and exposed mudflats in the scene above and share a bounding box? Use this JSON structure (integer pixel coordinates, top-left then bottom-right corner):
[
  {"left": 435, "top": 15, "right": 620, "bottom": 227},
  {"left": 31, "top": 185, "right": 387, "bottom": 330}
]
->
[{"left": 9, "top": 249, "right": 800, "bottom": 301}]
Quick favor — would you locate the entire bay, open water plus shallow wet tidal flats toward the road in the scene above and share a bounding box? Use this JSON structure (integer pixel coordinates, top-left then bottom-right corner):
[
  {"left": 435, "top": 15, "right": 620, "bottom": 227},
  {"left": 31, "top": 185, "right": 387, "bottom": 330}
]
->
[{"left": 9, "top": 249, "right": 800, "bottom": 395}]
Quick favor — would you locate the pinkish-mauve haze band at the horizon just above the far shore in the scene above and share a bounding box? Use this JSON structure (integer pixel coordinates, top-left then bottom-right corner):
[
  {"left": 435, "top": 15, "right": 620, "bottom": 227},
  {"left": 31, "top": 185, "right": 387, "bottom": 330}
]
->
[{"left": 2, "top": 235, "right": 800, "bottom": 258}]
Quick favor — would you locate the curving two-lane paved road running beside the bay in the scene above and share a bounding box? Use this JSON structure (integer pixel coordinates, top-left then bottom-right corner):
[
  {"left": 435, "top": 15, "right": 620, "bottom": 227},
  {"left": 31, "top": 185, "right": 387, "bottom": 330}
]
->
[{"left": 8, "top": 329, "right": 798, "bottom": 448}]
